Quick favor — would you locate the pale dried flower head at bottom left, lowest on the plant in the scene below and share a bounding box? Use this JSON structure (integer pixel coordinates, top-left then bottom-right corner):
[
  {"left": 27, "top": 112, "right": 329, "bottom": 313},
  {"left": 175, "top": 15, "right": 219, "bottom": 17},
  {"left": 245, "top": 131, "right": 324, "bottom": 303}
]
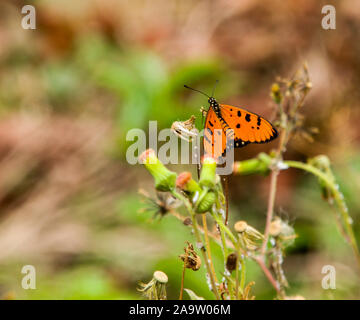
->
[{"left": 138, "top": 271, "right": 168, "bottom": 300}]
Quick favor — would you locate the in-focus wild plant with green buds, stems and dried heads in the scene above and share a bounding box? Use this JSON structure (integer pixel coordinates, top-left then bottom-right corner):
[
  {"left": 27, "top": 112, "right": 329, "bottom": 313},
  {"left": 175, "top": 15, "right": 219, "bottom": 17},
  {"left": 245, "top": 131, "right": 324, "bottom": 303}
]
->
[{"left": 140, "top": 65, "right": 360, "bottom": 300}]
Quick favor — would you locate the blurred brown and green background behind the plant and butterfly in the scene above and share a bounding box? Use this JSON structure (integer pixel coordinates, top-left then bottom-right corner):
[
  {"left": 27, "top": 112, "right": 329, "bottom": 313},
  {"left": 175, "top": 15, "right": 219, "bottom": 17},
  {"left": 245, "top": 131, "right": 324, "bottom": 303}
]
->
[{"left": 0, "top": 0, "right": 360, "bottom": 299}]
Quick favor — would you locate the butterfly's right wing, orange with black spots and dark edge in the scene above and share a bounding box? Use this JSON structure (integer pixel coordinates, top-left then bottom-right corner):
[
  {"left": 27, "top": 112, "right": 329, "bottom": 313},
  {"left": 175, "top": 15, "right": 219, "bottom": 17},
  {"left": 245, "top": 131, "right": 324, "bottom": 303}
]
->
[{"left": 215, "top": 104, "right": 278, "bottom": 148}]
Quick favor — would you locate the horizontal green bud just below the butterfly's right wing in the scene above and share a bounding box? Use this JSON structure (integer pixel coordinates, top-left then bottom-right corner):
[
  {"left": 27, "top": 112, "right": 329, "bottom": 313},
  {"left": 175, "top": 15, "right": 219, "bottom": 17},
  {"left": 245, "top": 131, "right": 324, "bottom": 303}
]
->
[{"left": 233, "top": 152, "right": 272, "bottom": 175}]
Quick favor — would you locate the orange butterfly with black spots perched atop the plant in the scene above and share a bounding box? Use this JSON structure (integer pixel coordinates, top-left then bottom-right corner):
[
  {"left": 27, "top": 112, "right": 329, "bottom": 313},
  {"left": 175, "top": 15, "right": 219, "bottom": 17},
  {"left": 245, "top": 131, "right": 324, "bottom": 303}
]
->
[{"left": 185, "top": 85, "right": 278, "bottom": 159}]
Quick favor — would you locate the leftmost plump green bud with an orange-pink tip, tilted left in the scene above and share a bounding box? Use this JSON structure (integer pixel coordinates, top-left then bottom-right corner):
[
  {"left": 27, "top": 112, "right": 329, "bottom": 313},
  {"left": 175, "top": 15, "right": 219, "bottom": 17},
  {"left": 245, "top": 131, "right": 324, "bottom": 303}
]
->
[{"left": 139, "top": 149, "right": 176, "bottom": 191}]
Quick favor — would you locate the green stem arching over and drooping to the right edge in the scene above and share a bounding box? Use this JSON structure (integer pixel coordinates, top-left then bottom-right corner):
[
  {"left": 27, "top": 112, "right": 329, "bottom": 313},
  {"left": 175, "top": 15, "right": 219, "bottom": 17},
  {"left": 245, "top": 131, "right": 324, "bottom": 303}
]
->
[{"left": 284, "top": 160, "right": 360, "bottom": 268}]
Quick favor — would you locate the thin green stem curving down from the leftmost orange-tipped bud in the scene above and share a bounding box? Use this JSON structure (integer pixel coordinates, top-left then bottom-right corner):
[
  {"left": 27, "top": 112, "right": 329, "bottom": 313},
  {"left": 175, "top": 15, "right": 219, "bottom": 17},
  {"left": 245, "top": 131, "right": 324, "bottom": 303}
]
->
[{"left": 171, "top": 190, "right": 220, "bottom": 300}]
